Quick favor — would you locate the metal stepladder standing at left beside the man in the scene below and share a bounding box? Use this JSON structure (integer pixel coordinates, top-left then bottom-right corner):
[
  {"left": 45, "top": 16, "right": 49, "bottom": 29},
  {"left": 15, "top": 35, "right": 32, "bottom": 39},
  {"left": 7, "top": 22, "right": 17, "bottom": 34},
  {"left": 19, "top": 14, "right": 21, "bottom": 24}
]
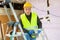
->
[{"left": 2, "top": 0, "right": 27, "bottom": 40}]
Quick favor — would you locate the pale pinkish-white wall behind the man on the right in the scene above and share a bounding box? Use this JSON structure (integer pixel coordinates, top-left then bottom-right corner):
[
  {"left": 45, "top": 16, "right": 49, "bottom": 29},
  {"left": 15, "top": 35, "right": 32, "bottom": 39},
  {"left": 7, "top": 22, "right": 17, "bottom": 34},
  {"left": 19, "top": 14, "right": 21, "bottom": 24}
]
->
[{"left": 27, "top": 0, "right": 60, "bottom": 40}]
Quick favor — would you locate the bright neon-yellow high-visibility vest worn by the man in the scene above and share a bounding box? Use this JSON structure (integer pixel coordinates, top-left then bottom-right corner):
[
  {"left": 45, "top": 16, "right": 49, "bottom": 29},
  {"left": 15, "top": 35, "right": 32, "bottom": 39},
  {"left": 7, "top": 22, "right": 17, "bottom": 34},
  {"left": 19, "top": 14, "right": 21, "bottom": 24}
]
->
[{"left": 20, "top": 12, "right": 38, "bottom": 30}]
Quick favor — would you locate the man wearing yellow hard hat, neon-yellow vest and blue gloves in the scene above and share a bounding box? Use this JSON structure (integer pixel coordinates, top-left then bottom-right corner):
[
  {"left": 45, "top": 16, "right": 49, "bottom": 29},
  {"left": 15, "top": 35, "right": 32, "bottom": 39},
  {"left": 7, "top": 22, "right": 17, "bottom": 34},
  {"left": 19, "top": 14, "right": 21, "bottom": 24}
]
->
[{"left": 20, "top": 2, "right": 42, "bottom": 40}]
